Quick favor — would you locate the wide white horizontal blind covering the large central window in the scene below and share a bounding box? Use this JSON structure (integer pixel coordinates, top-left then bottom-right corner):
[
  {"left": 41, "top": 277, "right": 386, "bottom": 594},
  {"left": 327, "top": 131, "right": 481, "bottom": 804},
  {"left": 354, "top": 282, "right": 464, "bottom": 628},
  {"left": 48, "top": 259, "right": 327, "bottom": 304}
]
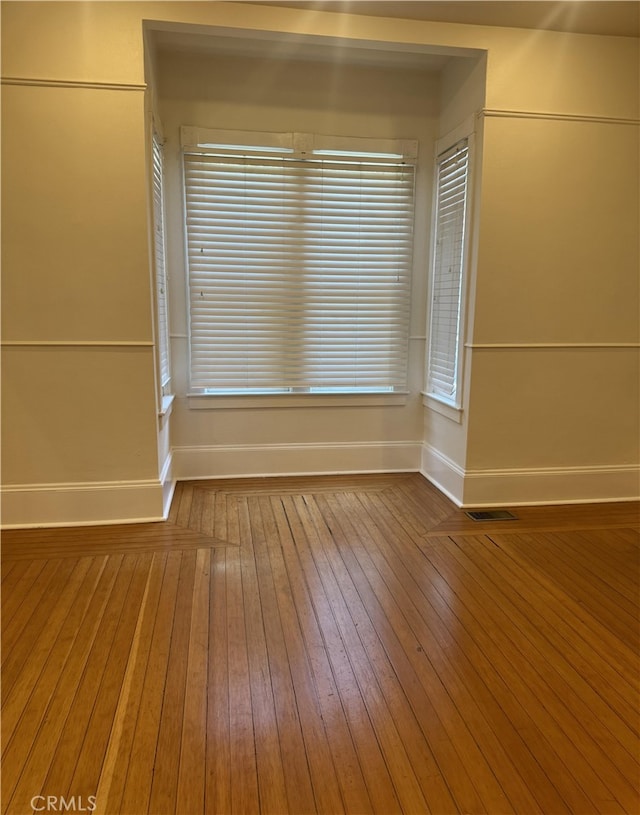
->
[{"left": 184, "top": 153, "right": 413, "bottom": 392}]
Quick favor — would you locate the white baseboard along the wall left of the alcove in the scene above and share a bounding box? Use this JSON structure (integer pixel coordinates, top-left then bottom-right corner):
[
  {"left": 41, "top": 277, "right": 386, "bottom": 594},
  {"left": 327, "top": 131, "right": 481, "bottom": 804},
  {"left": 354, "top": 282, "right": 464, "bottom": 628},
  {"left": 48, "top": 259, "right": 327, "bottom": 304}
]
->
[{"left": 2, "top": 479, "right": 164, "bottom": 529}]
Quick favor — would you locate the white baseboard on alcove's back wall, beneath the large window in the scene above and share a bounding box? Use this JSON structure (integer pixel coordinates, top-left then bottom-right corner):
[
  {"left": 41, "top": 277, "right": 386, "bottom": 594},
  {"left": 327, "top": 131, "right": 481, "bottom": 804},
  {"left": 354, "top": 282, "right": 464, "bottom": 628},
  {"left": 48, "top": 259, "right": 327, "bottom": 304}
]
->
[{"left": 172, "top": 441, "right": 420, "bottom": 479}]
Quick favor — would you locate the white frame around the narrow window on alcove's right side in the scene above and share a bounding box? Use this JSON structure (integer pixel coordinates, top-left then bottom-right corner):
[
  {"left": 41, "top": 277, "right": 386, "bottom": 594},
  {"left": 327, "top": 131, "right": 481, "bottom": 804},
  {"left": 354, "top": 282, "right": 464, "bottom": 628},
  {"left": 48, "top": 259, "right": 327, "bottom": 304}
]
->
[{"left": 423, "top": 117, "right": 475, "bottom": 423}]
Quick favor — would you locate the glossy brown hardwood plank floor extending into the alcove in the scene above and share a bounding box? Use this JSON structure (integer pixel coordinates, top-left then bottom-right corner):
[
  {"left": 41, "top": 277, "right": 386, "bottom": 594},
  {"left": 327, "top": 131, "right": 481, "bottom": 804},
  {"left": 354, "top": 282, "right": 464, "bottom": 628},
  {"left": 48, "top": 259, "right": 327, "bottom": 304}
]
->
[{"left": 2, "top": 474, "right": 640, "bottom": 815}]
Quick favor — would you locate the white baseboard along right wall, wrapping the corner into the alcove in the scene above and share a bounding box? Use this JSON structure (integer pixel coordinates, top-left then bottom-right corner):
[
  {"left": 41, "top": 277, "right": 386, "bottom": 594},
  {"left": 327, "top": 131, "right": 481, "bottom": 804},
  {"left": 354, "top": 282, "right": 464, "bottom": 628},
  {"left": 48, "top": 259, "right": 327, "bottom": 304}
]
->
[{"left": 420, "top": 445, "right": 640, "bottom": 508}]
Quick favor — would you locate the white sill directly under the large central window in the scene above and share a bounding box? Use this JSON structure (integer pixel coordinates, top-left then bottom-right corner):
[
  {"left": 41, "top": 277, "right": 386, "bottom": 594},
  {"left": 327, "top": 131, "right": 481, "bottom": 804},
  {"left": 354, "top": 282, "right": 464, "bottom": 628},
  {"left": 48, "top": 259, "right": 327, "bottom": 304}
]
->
[{"left": 187, "top": 392, "right": 409, "bottom": 410}]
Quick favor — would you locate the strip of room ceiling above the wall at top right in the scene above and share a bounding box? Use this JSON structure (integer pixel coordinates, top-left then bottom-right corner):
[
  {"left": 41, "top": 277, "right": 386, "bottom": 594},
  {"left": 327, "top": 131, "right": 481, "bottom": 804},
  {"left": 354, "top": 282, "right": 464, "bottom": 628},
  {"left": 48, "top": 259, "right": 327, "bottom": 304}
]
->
[{"left": 250, "top": 0, "right": 640, "bottom": 37}]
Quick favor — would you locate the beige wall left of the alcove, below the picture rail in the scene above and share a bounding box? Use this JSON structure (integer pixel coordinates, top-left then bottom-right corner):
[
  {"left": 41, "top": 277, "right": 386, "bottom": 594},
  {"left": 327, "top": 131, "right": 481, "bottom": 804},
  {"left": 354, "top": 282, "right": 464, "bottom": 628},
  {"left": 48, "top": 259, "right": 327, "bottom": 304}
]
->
[{"left": 2, "top": 25, "right": 162, "bottom": 522}]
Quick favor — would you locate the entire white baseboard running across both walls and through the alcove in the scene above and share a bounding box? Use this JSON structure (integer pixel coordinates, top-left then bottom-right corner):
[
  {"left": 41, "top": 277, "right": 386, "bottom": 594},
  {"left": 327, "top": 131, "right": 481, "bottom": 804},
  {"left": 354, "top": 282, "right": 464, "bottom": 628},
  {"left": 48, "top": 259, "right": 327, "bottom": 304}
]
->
[{"left": 1, "top": 441, "right": 640, "bottom": 529}]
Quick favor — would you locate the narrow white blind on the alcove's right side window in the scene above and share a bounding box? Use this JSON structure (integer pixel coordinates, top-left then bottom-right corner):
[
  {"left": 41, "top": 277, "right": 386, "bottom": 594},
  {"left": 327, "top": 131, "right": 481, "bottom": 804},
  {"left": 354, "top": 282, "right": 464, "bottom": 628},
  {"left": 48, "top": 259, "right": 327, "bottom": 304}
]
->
[{"left": 427, "top": 139, "right": 469, "bottom": 404}]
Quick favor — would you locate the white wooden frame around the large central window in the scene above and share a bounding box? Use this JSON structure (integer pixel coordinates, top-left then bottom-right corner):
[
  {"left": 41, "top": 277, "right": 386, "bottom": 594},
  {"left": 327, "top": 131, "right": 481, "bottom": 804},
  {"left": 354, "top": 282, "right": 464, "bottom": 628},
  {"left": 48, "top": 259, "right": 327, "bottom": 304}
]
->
[{"left": 181, "top": 127, "right": 418, "bottom": 407}]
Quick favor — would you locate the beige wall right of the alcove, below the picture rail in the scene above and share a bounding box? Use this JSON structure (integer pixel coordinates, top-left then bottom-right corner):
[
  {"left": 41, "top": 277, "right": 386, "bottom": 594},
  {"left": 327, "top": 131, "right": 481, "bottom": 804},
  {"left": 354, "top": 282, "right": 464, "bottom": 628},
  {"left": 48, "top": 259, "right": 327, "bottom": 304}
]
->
[{"left": 465, "top": 100, "right": 640, "bottom": 503}]
